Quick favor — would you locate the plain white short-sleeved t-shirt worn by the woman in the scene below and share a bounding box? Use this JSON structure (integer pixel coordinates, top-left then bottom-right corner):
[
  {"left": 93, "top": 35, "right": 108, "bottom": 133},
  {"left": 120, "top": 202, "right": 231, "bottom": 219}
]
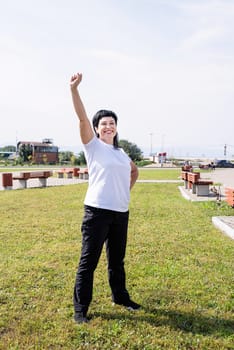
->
[{"left": 84, "top": 136, "right": 131, "bottom": 212}]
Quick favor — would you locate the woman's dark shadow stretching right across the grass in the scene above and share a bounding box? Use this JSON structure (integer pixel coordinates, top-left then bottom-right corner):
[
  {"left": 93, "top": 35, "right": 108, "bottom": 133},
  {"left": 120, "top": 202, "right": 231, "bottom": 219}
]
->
[{"left": 92, "top": 307, "right": 234, "bottom": 337}]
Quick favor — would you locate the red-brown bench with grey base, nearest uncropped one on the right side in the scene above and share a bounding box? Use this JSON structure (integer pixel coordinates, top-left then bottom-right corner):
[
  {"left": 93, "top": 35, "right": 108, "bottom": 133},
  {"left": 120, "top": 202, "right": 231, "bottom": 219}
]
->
[{"left": 181, "top": 171, "right": 213, "bottom": 196}]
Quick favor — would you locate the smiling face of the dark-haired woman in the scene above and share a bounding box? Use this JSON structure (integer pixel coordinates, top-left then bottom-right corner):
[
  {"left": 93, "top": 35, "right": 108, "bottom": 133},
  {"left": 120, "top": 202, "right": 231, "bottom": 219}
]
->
[{"left": 95, "top": 117, "right": 117, "bottom": 145}]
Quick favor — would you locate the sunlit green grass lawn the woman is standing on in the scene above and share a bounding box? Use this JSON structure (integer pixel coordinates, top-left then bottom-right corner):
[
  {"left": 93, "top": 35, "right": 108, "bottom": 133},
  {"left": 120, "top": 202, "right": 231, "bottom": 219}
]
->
[{"left": 0, "top": 179, "right": 234, "bottom": 350}]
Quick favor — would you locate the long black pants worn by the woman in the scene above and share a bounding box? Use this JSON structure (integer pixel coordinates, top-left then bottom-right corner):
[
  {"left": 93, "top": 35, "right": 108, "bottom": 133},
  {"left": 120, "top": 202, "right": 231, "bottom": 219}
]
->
[{"left": 73, "top": 206, "right": 129, "bottom": 313}]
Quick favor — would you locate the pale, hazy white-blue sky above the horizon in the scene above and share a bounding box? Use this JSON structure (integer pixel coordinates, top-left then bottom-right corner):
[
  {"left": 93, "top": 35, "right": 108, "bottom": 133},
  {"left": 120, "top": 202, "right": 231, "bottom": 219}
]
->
[{"left": 0, "top": 0, "right": 234, "bottom": 158}]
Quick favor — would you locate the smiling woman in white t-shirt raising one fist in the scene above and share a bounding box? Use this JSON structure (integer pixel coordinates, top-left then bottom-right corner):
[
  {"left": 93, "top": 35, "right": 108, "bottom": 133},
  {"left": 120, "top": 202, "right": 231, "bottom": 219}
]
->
[{"left": 70, "top": 73, "right": 140, "bottom": 323}]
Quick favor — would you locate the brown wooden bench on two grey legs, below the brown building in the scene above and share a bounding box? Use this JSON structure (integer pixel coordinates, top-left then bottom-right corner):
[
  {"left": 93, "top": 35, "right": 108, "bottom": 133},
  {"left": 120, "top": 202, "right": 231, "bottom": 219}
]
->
[{"left": 12, "top": 171, "right": 53, "bottom": 188}]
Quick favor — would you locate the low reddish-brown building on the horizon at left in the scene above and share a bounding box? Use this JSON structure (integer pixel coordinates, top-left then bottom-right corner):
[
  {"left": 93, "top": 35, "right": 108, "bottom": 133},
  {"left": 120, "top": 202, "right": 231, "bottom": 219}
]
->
[{"left": 17, "top": 139, "right": 59, "bottom": 164}]
